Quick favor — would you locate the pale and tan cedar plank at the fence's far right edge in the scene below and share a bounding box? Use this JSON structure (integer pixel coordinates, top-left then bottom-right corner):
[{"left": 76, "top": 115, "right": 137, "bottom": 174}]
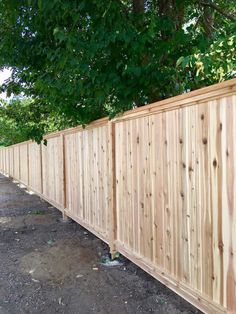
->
[{"left": 223, "top": 97, "right": 236, "bottom": 313}]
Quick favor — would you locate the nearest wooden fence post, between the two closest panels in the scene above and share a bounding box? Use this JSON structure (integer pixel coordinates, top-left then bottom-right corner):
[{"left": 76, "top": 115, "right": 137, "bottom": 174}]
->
[{"left": 108, "top": 121, "right": 117, "bottom": 258}]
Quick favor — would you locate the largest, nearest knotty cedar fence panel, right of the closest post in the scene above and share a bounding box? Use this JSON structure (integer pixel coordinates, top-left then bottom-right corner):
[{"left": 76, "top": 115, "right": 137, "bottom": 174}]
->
[{"left": 115, "top": 96, "right": 236, "bottom": 313}]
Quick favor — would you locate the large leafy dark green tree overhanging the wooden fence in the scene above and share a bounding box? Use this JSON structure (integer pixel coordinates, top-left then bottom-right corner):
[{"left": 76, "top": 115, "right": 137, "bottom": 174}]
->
[{"left": 0, "top": 0, "right": 235, "bottom": 142}]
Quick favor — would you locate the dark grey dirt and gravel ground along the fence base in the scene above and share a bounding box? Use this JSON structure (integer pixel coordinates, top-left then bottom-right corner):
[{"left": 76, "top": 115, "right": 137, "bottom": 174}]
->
[{"left": 0, "top": 175, "right": 200, "bottom": 314}]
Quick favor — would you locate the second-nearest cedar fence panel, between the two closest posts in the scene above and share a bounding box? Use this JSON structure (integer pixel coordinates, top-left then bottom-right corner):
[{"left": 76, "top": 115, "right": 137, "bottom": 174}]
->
[{"left": 65, "top": 122, "right": 109, "bottom": 242}]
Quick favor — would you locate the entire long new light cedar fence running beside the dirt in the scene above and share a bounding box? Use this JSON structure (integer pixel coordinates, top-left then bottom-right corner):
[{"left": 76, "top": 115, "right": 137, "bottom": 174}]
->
[{"left": 0, "top": 79, "right": 236, "bottom": 313}]
